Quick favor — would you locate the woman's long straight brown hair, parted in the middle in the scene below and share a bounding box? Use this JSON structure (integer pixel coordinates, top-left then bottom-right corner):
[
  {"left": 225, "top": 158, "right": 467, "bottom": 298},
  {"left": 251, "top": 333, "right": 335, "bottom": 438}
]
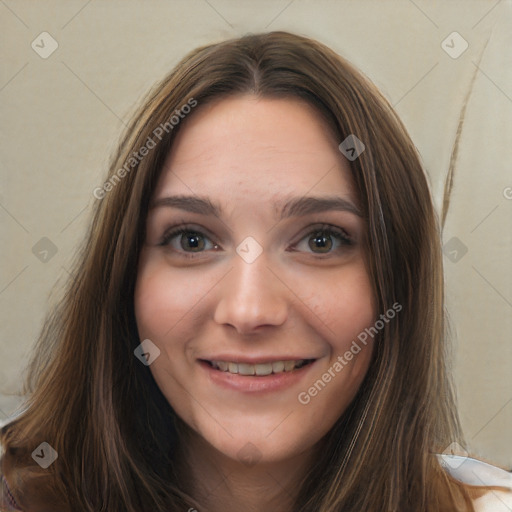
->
[{"left": 2, "top": 32, "right": 480, "bottom": 512}]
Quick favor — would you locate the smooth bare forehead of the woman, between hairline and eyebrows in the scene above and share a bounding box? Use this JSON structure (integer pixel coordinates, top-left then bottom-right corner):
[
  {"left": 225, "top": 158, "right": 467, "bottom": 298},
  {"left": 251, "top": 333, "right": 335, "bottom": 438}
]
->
[{"left": 154, "top": 95, "right": 356, "bottom": 201}]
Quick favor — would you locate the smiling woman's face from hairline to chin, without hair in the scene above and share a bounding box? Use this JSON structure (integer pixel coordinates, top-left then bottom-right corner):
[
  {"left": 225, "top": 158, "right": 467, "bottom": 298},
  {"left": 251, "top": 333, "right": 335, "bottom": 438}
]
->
[{"left": 135, "top": 96, "right": 376, "bottom": 462}]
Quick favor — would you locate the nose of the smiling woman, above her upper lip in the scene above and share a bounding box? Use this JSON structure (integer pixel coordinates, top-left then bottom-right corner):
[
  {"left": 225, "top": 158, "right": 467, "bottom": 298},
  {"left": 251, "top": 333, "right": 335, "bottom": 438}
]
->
[{"left": 214, "top": 254, "right": 289, "bottom": 334}]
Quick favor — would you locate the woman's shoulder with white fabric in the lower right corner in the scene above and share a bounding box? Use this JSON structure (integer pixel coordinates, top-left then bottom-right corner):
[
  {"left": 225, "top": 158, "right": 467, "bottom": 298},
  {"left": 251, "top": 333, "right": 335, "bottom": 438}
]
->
[{"left": 438, "top": 454, "right": 512, "bottom": 512}]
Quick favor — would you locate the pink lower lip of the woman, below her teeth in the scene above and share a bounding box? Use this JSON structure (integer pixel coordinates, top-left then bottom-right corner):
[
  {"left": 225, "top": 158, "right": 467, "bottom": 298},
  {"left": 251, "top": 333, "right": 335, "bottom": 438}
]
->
[{"left": 199, "top": 361, "right": 316, "bottom": 393}]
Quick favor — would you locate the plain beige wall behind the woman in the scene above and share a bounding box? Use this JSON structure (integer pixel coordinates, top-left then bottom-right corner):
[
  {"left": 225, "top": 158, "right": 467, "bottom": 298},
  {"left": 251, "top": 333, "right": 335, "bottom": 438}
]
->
[{"left": 0, "top": 0, "right": 512, "bottom": 469}]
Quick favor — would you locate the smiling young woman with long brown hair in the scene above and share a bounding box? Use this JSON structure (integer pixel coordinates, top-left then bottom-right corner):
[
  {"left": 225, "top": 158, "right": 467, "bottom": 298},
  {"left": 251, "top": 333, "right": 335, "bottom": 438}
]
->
[{"left": 2, "top": 32, "right": 512, "bottom": 512}]
